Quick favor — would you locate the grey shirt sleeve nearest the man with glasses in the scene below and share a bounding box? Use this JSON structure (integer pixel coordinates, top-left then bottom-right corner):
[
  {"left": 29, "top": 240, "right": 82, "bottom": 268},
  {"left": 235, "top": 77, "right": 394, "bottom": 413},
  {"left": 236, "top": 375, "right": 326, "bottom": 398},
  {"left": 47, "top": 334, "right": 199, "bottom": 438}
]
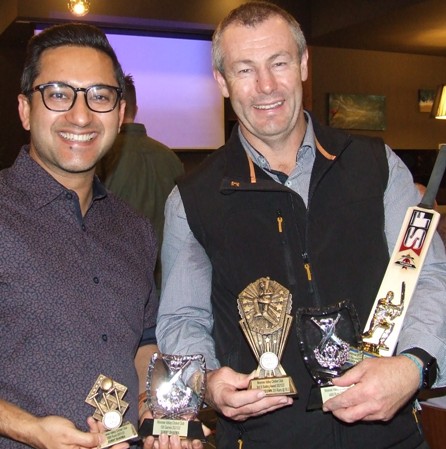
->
[{"left": 156, "top": 187, "right": 220, "bottom": 369}]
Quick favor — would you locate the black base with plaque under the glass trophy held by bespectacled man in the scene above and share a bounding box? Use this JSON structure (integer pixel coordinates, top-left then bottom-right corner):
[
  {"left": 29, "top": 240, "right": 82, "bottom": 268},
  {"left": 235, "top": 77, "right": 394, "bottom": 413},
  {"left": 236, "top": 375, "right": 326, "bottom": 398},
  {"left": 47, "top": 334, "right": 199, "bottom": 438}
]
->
[{"left": 139, "top": 419, "right": 206, "bottom": 443}]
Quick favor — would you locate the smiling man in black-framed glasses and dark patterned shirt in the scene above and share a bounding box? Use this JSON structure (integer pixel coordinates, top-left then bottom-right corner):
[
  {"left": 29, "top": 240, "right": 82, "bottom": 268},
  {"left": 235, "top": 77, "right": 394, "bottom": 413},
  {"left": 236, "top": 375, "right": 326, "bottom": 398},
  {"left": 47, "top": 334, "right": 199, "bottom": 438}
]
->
[{"left": 0, "top": 24, "right": 199, "bottom": 449}]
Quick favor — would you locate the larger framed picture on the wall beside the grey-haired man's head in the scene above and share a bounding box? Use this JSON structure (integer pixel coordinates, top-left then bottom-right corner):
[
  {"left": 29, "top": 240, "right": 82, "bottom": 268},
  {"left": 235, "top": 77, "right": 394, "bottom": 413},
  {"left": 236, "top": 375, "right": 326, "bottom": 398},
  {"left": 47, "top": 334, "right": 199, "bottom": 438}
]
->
[{"left": 328, "top": 94, "right": 386, "bottom": 131}]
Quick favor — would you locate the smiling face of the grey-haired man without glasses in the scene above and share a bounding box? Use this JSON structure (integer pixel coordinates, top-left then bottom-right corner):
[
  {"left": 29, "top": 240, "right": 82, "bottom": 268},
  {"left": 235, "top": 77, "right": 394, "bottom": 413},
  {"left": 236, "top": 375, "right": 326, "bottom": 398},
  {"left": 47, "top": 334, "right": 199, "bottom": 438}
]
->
[{"left": 214, "top": 16, "right": 308, "bottom": 146}]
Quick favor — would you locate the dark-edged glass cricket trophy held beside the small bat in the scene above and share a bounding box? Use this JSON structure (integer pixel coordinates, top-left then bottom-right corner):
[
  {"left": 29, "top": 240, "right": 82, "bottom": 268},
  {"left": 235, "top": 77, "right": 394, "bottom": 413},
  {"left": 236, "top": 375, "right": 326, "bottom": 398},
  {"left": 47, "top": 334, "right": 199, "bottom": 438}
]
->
[{"left": 296, "top": 301, "right": 364, "bottom": 410}]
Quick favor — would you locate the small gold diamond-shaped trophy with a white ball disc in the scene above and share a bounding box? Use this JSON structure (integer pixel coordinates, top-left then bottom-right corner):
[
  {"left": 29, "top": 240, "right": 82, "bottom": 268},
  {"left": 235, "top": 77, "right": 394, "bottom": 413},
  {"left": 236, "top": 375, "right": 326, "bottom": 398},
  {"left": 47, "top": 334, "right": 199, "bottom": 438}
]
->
[{"left": 85, "top": 374, "right": 138, "bottom": 448}]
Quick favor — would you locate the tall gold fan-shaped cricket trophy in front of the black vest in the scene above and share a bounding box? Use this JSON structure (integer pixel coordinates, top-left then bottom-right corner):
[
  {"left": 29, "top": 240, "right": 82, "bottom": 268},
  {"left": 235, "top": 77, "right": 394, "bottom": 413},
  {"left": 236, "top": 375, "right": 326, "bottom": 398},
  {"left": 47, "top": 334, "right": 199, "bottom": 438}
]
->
[{"left": 237, "top": 277, "right": 297, "bottom": 396}]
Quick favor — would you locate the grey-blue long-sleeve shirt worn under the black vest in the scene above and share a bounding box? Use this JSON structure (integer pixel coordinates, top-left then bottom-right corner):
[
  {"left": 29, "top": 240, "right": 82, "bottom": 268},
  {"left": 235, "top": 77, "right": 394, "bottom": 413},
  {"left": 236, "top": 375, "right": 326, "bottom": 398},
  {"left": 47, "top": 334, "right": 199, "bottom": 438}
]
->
[{"left": 157, "top": 116, "right": 446, "bottom": 386}]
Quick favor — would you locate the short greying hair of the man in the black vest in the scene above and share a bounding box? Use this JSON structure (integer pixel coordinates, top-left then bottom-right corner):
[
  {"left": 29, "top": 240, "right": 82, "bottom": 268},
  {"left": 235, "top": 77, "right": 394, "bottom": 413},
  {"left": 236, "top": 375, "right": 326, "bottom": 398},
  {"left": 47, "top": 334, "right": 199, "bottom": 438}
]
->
[{"left": 212, "top": 1, "right": 307, "bottom": 74}]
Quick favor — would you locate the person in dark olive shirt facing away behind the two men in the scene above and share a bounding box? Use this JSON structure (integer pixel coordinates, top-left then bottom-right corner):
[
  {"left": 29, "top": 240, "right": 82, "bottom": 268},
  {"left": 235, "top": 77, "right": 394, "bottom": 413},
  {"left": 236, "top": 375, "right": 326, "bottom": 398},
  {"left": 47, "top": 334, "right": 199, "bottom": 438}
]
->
[{"left": 97, "top": 75, "right": 184, "bottom": 287}]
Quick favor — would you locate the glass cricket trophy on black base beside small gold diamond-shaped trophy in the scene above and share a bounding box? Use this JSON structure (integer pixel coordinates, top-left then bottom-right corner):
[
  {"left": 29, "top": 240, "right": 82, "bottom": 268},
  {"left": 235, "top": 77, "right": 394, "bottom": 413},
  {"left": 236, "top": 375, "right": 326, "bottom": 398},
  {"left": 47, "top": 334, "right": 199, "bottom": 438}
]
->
[{"left": 139, "top": 353, "right": 206, "bottom": 442}]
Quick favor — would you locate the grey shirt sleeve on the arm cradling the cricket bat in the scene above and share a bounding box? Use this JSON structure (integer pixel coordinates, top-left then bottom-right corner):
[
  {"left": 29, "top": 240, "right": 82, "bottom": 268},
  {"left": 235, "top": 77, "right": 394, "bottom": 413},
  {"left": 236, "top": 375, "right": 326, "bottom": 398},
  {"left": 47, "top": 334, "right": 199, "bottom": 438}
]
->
[{"left": 384, "top": 146, "right": 446, "bottom": 387}]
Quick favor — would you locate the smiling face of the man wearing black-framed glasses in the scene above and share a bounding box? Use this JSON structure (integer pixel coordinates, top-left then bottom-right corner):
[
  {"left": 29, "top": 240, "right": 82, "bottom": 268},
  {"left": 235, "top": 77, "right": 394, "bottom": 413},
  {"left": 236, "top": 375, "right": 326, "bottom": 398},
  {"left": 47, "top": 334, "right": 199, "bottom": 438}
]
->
[{"left": 19, "top": 46, "right": 125, "bottom": 184}]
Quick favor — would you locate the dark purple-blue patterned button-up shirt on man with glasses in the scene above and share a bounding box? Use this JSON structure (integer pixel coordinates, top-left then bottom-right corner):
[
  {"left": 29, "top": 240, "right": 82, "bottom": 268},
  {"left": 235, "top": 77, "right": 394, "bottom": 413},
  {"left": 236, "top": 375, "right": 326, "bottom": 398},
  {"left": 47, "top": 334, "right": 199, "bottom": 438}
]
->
[{"left": 0, "top": 147, "right": 157, "bottom": 449}]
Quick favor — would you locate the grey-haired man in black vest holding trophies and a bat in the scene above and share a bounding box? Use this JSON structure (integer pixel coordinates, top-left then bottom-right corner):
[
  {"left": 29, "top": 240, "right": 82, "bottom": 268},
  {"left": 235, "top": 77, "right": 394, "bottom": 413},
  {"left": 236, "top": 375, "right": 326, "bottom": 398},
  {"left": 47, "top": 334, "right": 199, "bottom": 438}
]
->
[{"left": 157, "top": 1, "right": 446, "bottom": 449}]
